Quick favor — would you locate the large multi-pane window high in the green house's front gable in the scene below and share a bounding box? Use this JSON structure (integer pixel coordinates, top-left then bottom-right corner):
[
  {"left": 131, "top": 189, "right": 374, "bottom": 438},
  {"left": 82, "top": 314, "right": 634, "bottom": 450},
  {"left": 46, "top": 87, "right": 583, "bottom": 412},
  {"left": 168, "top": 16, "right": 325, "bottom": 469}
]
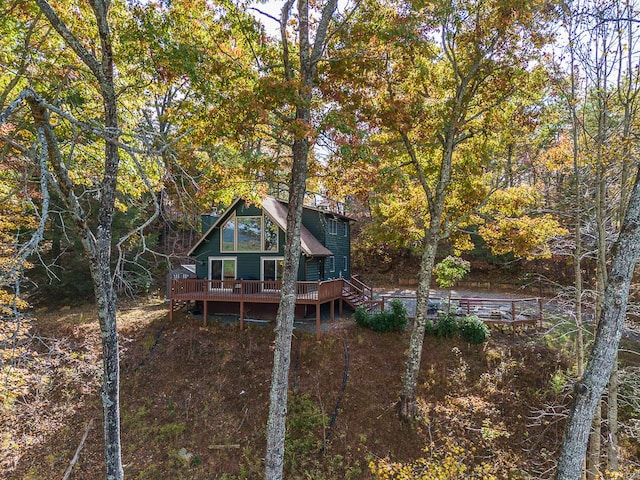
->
[{"left": 220, "top": 215, "right": 279, "bottom": 252}]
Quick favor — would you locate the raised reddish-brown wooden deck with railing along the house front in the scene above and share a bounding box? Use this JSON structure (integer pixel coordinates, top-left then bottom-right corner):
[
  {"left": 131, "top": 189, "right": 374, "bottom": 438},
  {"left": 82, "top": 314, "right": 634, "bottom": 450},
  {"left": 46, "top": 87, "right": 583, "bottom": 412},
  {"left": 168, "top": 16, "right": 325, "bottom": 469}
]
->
[{"left": 169, "top": 278, "right": 343, "bottom": 337}]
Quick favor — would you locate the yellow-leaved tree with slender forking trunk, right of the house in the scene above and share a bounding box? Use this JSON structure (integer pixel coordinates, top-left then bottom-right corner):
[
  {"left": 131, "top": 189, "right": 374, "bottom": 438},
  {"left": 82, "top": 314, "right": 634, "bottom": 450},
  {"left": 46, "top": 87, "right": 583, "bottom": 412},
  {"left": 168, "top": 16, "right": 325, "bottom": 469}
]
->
[{"left": 328, "top": 0, "right": 556, "bottom": 419}]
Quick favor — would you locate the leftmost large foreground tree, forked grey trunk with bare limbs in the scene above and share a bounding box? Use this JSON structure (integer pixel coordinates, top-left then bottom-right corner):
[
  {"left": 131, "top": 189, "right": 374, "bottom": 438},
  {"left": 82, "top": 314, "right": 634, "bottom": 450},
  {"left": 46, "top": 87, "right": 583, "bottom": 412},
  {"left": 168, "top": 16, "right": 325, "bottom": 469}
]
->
[{"left": 0, "top": 0, "right": 123, "bottom": 479}]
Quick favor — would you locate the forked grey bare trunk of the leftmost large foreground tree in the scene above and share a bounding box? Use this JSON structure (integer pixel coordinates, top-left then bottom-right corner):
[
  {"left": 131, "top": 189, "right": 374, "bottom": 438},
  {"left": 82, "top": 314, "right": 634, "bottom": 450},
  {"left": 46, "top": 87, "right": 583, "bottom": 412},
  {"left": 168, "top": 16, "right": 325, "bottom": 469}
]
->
[{"left": 31, "top": 0, "right": 124, "bottom": 480}]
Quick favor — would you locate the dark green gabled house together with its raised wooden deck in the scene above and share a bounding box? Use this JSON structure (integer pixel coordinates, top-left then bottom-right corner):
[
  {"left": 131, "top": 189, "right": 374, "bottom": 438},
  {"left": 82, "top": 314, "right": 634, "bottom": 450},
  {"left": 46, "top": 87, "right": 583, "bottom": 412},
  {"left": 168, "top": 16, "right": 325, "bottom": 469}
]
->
[{"left": 171, "top": 197, "right": 373, "bottom": 333}]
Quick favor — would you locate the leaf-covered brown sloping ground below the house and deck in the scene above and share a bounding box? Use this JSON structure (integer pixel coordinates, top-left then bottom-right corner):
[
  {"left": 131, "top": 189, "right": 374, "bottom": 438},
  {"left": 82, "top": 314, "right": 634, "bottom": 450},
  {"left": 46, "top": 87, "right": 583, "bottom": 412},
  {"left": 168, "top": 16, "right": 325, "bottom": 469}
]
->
[{"left": 0, "top": 299, "right": 636, "bottom": 480}]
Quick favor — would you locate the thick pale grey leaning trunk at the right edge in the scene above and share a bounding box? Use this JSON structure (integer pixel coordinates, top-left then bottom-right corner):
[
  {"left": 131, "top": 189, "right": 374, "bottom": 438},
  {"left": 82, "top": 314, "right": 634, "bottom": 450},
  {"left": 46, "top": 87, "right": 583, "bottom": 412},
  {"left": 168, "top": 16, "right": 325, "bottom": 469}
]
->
[{"left": 556, "top": 166, "right": 640, "bottom": 480}]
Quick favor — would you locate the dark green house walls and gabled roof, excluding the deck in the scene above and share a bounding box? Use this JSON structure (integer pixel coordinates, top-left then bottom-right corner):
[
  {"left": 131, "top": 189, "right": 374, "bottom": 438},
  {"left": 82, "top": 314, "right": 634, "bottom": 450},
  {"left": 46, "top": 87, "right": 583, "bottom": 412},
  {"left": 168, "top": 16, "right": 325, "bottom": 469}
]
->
[{"left": 189, "top": 197, "right": 352, "bottom": 282}]
